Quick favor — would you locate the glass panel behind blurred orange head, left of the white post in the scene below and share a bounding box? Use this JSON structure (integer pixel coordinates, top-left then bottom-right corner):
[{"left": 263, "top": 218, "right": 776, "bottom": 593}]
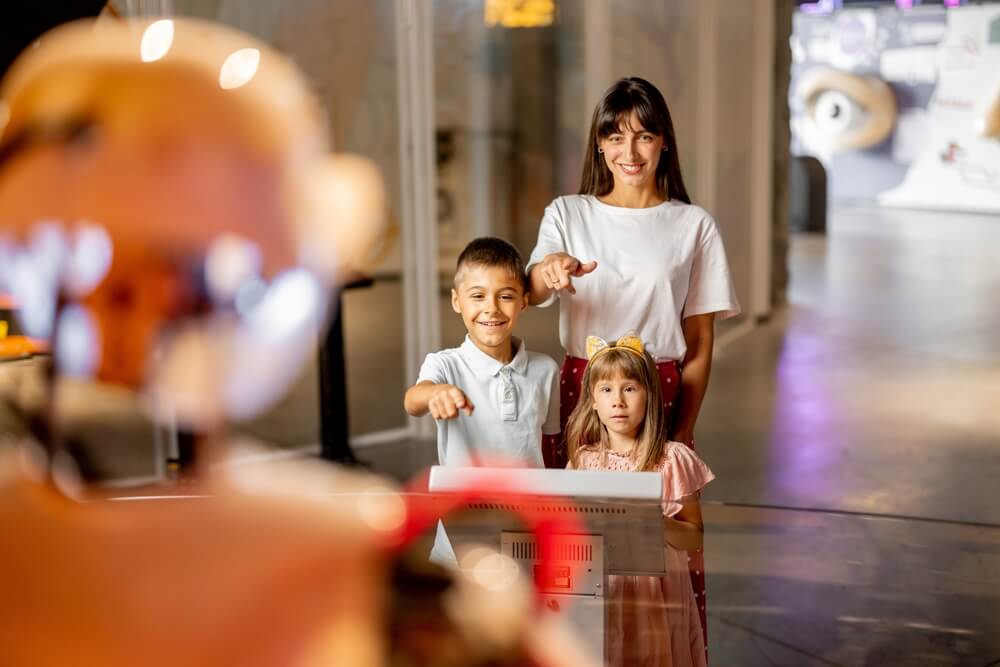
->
[{"left": 174, "top": 0, "right": 412, "bottom": 445}]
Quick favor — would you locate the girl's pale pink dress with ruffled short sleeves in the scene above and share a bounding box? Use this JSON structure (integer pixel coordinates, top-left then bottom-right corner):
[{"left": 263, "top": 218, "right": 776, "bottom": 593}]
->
[{"left": 576, "top": 442, "right": 715, "bottom": 667}]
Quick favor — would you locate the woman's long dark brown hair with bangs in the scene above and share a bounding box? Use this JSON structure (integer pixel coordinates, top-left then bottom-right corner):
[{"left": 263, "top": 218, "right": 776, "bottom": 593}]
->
[{"left": 580, "top": 76, "right": 691, "bottom": 204}]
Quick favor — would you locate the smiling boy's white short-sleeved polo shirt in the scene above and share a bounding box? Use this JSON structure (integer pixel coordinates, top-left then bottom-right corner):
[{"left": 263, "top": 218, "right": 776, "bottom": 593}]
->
[{"left": 417, "top": 335, "right": 559, "bottom": 468}]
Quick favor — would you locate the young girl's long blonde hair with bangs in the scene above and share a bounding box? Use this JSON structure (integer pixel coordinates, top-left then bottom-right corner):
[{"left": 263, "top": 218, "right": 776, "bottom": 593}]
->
[{"left": 566, "top": 347, "right": 667, "bottom": 471}]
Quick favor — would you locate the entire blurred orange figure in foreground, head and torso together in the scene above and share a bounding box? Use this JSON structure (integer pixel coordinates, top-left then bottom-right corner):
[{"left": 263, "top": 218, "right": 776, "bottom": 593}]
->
[{"left": 0, "top": 15, "right": 592, "bottom": 666}]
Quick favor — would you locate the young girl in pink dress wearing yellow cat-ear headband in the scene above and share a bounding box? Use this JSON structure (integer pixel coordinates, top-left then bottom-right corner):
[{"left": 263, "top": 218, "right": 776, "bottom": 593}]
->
[{"left": 566, "top": 336, "right": 715, "bottom": 667}]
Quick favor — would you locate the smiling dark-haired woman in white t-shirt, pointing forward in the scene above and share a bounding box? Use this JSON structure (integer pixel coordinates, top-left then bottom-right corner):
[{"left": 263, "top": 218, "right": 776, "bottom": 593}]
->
[{"left": 528, "top": 77, "right": 740, "bottom": 656}]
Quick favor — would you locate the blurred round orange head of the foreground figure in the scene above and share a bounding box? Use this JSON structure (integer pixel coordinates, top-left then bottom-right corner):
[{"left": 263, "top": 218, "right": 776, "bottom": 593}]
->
[{"left": 0, "top": 20, "right": 384, "bottom": 438}]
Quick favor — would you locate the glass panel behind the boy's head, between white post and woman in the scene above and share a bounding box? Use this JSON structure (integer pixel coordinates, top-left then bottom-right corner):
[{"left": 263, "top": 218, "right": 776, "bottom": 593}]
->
[{"left": 433, "top": 0, "right": 585, "bottom": 359}]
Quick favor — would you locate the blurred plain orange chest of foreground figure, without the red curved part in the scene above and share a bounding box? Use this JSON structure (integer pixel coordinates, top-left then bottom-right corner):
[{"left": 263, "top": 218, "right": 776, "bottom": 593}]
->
[{"left": 0, "top": 460, "right": 398, "bottom": 667}]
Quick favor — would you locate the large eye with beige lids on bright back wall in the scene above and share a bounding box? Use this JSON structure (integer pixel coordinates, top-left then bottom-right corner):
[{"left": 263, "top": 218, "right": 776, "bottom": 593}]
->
[{"left": 796, "top": 69, "right": 897, "bottom": 151}]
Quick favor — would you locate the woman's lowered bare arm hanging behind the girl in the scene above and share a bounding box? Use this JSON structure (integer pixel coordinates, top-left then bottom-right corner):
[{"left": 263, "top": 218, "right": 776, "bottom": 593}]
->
[{"left": 670, "top": 313, "right": 715, "bottom": 445}]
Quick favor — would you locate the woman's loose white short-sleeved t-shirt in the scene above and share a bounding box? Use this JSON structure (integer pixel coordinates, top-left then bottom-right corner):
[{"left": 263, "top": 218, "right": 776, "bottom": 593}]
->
[{"left": 528, "top": 195, "right": 740, "bottom": 361}]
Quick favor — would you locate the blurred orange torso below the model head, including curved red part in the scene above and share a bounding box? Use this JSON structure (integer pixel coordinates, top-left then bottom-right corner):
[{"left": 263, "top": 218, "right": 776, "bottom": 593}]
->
[{"left": 0, "top": 450, "right": 596, "bottom": 667}]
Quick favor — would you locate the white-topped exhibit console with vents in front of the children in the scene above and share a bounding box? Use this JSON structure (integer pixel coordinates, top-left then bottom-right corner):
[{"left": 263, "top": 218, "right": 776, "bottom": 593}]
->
[{"left": 428, "top": 466, "right": 666, "bottom": 656}]
